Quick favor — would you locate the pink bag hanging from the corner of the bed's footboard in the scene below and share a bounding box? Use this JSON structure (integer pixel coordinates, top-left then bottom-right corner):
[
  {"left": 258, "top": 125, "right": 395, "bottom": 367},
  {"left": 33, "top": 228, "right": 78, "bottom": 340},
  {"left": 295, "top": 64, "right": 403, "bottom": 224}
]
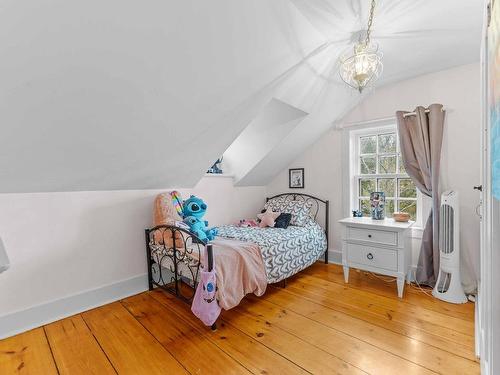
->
[{"left": 191, "top": 247, "right": 221, "bottom": 326}]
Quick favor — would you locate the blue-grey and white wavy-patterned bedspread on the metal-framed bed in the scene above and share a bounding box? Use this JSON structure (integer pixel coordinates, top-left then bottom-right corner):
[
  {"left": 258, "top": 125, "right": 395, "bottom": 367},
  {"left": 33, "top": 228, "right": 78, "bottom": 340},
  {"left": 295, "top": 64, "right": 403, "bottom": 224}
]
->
[{"left": 218, "top": 221, "right": 326, "bottom": 284}]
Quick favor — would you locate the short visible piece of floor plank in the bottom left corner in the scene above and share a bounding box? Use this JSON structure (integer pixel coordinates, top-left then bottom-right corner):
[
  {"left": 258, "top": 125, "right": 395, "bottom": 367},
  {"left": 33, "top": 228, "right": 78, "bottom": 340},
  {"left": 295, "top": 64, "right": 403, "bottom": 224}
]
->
[{"left": 0, "top": 328, "right": 57, "bottom": 375}]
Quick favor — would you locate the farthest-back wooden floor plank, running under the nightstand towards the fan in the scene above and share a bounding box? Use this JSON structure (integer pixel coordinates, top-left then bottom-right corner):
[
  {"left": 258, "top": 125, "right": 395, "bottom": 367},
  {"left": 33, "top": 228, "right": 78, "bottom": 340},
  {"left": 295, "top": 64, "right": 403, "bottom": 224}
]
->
[{"left": 301, "top": 263, "right": 474, "bottom": 321}]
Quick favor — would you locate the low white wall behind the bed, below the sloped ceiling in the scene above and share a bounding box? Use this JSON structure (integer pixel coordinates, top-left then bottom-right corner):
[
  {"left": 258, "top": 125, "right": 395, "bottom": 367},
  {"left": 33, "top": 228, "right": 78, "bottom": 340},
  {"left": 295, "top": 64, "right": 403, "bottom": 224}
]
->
[{"left": 0, "top": 176, "right": 265, "bottom": 337}]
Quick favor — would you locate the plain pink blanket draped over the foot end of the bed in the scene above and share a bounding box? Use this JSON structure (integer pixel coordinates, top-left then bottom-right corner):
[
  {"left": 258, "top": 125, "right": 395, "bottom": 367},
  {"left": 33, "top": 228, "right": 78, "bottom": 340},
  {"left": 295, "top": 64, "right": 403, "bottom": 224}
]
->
[{"left": 211, "top": 238, "right": 267, "bottom": 310}]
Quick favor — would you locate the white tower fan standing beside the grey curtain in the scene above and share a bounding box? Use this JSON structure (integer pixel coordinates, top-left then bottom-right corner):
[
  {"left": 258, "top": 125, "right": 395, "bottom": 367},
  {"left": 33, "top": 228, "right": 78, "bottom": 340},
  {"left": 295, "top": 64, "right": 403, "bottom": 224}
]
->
[{"left": 432, "top": 190, "right": 467, "bottom": 303}]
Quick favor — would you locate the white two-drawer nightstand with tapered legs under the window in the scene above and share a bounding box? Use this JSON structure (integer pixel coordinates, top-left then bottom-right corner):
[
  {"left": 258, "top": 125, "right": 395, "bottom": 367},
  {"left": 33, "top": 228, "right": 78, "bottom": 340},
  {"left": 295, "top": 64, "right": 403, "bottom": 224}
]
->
[{"left": 339, "top": 217, "right": 414, "bottom": 298}]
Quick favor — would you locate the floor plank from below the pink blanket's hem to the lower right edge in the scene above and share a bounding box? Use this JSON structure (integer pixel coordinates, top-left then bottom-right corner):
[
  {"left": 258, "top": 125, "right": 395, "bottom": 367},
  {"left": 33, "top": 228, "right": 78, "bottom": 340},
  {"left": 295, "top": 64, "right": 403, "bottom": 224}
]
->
[{"left": 228, "top": 301, "right": 438, "bottom": 374}]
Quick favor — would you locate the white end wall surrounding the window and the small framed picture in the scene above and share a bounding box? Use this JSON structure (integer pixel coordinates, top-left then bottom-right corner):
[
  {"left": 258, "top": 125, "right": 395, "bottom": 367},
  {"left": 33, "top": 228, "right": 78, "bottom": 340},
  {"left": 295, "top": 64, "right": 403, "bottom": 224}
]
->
[{"left": 267, "top": 64, "right": 481, "bottom": 289}]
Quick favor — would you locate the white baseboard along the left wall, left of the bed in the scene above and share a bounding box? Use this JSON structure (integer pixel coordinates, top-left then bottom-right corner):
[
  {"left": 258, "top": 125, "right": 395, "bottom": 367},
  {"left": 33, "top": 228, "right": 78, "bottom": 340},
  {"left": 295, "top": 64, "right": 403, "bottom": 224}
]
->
[{"left": 0, "top": 274, "right": 148, "bottom": 339}]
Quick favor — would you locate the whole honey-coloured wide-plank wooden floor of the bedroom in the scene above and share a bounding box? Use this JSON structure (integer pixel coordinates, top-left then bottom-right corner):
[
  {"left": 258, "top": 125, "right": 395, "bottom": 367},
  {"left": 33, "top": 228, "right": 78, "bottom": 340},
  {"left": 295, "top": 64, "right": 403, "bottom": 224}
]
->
[{"left": 0, "top": 263, "right": 479, "bottom": 375}]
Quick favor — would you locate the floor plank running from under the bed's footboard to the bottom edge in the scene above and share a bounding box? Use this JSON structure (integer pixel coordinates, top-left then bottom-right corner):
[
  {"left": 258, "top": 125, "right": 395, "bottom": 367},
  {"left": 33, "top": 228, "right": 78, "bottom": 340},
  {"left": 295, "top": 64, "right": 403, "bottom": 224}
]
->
[{"left": 150, "top": 291, "right": 308, "bottom": 374}]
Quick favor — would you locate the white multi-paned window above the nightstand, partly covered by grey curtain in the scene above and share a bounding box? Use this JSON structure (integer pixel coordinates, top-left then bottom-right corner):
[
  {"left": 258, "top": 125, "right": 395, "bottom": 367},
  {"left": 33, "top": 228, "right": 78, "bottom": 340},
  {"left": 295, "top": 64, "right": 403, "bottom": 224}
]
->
[{"left": 350, "top": 125, "right": 420, "bottom": 221}]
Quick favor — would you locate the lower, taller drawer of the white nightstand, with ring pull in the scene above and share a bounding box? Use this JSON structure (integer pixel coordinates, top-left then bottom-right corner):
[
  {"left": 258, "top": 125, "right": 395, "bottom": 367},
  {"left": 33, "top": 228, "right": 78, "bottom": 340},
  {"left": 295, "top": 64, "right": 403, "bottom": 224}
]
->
[{"left": 347, "top": 243, "right": 398, "bottom": 271}]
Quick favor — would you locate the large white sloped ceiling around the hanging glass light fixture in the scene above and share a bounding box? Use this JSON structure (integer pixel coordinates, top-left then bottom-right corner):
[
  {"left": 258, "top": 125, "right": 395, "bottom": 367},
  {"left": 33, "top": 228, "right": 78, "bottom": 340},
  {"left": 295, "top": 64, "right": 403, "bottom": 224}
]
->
[{"left": 0, "top": 0, "right": 482, "bottom": 192}]
